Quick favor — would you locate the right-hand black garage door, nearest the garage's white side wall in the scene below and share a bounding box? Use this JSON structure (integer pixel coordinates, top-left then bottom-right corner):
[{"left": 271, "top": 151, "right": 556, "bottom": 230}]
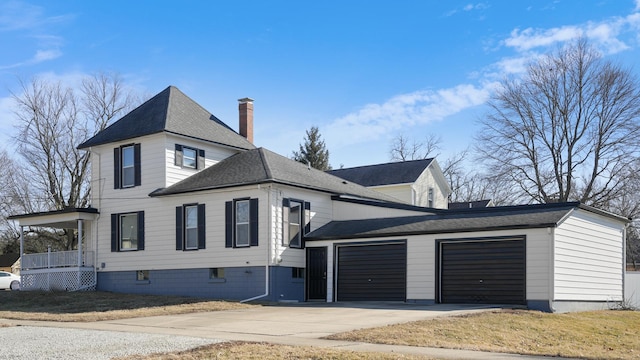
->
[{"left": 439, "top": 238, "right": 526, "bottom": 304}]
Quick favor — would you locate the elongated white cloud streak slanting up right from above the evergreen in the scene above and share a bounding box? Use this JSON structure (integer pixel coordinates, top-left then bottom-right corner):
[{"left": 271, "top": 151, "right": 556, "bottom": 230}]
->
[{"left": 323, "top": 83, "right": 493, "bottom": 147}]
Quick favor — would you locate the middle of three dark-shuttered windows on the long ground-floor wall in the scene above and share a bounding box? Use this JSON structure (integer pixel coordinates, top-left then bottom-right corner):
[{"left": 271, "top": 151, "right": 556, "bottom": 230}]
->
[{"left": 176, "top": 204, "right": 206, "bottom": 250}]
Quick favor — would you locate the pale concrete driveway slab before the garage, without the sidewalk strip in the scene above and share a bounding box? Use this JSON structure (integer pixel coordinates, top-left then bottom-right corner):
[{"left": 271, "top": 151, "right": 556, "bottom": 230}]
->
[{"left": 63, "top": 302, "right": 500, "bottom": 345}]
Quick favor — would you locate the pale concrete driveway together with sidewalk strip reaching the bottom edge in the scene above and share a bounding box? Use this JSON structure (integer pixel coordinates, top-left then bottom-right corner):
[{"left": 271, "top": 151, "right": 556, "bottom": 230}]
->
[{"left": 0, "top": 303, "right": 580, "bottom": 360}]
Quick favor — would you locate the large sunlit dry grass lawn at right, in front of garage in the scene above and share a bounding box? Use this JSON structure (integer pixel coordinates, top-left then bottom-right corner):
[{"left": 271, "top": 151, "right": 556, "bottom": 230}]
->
[{"left": 327, "top": 311, "right": 640, "bottom": 359}]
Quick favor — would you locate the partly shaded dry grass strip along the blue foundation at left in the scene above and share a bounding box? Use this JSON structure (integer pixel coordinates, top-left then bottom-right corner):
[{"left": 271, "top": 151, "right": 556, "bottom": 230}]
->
[{"left": 0, "top": 291, "right": 252, "bottom": 322}]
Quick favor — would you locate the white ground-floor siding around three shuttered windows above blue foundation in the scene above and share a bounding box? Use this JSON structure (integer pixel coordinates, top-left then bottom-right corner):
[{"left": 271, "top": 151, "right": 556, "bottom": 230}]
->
[{"left": 98, "top": 186, "right": 271, "bottom": 272}]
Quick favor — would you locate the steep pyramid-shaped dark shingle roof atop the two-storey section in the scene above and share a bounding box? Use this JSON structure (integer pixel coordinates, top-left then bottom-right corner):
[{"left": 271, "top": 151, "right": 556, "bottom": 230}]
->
[{"left": 78, "top": 86, "right": 255, "bottom": 149}]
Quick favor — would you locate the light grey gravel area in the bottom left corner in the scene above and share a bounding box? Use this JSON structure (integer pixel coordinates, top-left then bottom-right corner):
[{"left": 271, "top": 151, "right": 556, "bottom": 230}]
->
[{"left": 0, "top": 326, "right": 222, "bottom": 360}]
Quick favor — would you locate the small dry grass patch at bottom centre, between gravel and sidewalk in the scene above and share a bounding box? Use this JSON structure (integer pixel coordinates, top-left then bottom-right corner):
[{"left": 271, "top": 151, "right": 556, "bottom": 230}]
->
[{"left": 118, "top": 341, "right": 433, "bottom": 360}]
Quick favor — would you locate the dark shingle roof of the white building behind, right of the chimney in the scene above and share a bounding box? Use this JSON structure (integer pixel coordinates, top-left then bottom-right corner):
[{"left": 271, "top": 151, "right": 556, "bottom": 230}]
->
[{"left": 327, "top": 159, "right": 433, "bottom": 186}]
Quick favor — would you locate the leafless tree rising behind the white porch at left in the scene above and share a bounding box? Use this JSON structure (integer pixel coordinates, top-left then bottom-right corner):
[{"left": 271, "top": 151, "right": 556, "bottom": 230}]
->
[{"left": 5, "top": 73, "right": 136, "bottom": 249}]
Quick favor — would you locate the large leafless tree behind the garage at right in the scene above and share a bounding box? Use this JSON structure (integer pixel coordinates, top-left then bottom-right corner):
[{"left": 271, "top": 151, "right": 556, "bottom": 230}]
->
[{"left": 477, "top": 39, "right": 640, "bottom": 209}]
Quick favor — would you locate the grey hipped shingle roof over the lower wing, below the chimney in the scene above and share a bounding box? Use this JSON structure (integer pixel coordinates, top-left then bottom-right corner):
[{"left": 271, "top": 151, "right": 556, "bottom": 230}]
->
[{"left": 150, "top": 148, "right": 398, "bottom": 203}]
